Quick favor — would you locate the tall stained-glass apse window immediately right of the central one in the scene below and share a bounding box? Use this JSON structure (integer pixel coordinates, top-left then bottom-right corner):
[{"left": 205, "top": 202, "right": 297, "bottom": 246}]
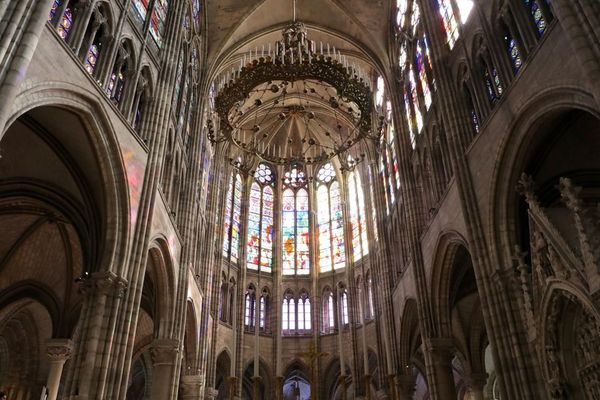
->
[{"left": 317, "top": 163, "right": 346, "bottom": 272}]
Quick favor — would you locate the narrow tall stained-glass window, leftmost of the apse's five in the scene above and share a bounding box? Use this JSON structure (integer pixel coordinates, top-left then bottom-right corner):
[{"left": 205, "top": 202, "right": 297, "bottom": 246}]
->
[{"left": 223, "top": 174, "right": 242, "bottom": 263}]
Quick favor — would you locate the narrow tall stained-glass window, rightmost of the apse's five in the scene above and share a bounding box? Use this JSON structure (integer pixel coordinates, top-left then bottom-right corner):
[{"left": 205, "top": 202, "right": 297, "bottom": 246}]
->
[{"left": 348, "top": 171, "right": 369, "bottom": 262}]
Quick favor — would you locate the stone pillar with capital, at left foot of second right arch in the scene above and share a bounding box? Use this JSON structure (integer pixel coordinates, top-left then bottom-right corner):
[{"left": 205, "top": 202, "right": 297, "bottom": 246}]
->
[{"left": 426, "top": 338, "right": 456, "bottom": 399}]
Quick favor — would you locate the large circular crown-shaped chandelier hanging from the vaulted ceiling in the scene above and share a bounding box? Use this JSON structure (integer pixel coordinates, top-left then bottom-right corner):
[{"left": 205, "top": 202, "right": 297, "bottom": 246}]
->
[{"left": 208, "top": 21, "right": 375, "bottom": 165}]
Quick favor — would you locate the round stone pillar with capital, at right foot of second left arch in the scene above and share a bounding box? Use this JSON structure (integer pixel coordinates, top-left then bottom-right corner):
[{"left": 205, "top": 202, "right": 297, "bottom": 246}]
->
[{"left": 150, "top": 339, "right": 179, "bottom": 400}]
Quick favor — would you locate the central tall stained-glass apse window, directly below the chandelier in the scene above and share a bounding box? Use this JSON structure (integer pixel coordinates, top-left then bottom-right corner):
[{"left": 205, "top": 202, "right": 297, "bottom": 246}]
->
[{"left": 282, "top": 165, "right": 310, "bottom": 275}]
